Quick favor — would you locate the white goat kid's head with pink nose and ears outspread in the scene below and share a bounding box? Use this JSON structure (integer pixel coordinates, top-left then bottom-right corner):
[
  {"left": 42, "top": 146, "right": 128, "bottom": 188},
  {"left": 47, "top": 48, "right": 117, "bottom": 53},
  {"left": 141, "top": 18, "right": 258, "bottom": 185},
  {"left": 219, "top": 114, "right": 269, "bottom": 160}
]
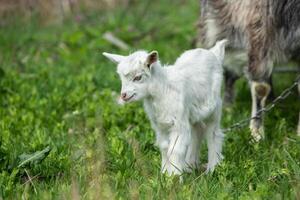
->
[{"left": 103, "top": 51, "right": 160, "bottom": 103}]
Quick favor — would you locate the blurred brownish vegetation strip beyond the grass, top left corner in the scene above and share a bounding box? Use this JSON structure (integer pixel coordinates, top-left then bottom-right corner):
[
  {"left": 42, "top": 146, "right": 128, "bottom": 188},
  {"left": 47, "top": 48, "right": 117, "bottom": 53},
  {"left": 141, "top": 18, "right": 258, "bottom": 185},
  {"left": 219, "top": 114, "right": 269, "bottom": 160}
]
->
[{"left": 0, "top": 0, "right": 127, "bottom": 25}]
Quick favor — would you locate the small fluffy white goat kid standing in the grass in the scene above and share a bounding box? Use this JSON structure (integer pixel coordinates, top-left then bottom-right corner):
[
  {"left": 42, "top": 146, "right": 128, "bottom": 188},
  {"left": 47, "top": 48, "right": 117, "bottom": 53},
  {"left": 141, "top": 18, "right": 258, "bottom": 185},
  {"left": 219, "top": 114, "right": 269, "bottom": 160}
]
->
[{"left": 103, "top": 40, "right": 226, "bottom": 174}]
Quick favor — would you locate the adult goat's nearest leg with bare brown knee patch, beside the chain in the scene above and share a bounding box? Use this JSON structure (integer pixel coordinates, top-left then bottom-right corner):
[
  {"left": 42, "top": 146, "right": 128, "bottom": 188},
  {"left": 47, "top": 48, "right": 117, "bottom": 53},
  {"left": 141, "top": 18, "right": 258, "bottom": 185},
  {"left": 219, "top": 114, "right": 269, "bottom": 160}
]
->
[{"left": 248, "top": 27, "right": 273, "bottom": 141}]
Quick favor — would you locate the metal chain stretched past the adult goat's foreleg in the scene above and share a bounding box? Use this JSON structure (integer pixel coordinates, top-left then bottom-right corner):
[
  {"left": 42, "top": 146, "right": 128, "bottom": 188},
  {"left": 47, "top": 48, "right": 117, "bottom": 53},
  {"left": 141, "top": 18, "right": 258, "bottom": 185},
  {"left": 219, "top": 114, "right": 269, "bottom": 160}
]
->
[{"left": 223, "top": 75, "right": 300, "bottom": 133}]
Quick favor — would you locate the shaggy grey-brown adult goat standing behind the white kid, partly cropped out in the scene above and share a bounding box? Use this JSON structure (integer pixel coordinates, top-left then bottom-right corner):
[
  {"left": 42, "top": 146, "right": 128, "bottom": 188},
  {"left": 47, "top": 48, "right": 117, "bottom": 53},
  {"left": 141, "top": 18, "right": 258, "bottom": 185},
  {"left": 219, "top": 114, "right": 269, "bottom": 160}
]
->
[{"left": 198, "top": 0, "right": 300, "bottom": 141}]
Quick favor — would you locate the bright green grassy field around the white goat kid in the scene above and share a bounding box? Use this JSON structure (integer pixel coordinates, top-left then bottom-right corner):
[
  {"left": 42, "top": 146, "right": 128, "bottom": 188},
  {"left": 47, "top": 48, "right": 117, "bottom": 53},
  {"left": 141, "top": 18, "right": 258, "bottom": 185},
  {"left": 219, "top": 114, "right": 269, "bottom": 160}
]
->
[{"left": 0, "top": 0, "right": 300, "bottom": 199}]
